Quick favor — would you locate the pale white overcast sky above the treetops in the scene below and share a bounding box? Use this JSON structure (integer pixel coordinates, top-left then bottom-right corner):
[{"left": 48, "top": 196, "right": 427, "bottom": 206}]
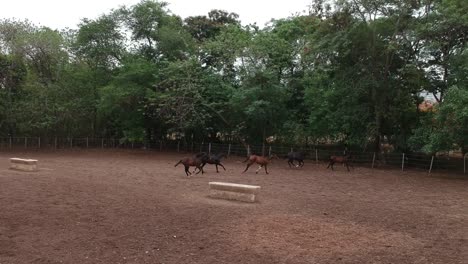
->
[{"left": 0, "top": 0, "right": 311, "bottom": 29}]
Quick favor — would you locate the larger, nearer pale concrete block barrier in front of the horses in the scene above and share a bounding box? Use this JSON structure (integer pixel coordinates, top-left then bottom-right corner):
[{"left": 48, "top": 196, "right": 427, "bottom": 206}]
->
[{"left": 208, "top": 182, "right": 260, "bottom": 203}]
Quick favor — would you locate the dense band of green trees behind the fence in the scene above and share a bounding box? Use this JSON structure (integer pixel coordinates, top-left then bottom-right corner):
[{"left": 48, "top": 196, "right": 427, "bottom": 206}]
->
[{"left": 0, "top": 0, "right": 468, "bottom": 152}]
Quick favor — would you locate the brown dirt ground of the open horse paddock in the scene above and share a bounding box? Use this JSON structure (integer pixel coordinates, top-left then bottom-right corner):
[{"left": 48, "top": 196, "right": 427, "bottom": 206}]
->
[{"left": 0, "top": 151, "right": 468, "bottom": 264}]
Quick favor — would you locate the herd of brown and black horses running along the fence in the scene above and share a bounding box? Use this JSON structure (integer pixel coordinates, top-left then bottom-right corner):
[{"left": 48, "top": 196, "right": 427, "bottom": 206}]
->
[{"left": 174, "top": 151, "right": 354, "bottom": 176}]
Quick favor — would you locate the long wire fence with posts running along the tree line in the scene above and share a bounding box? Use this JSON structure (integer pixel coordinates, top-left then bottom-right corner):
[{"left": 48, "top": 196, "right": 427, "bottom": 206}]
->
[{"left": 0, "top": 137, "right": 468, "bottom": 174}]
